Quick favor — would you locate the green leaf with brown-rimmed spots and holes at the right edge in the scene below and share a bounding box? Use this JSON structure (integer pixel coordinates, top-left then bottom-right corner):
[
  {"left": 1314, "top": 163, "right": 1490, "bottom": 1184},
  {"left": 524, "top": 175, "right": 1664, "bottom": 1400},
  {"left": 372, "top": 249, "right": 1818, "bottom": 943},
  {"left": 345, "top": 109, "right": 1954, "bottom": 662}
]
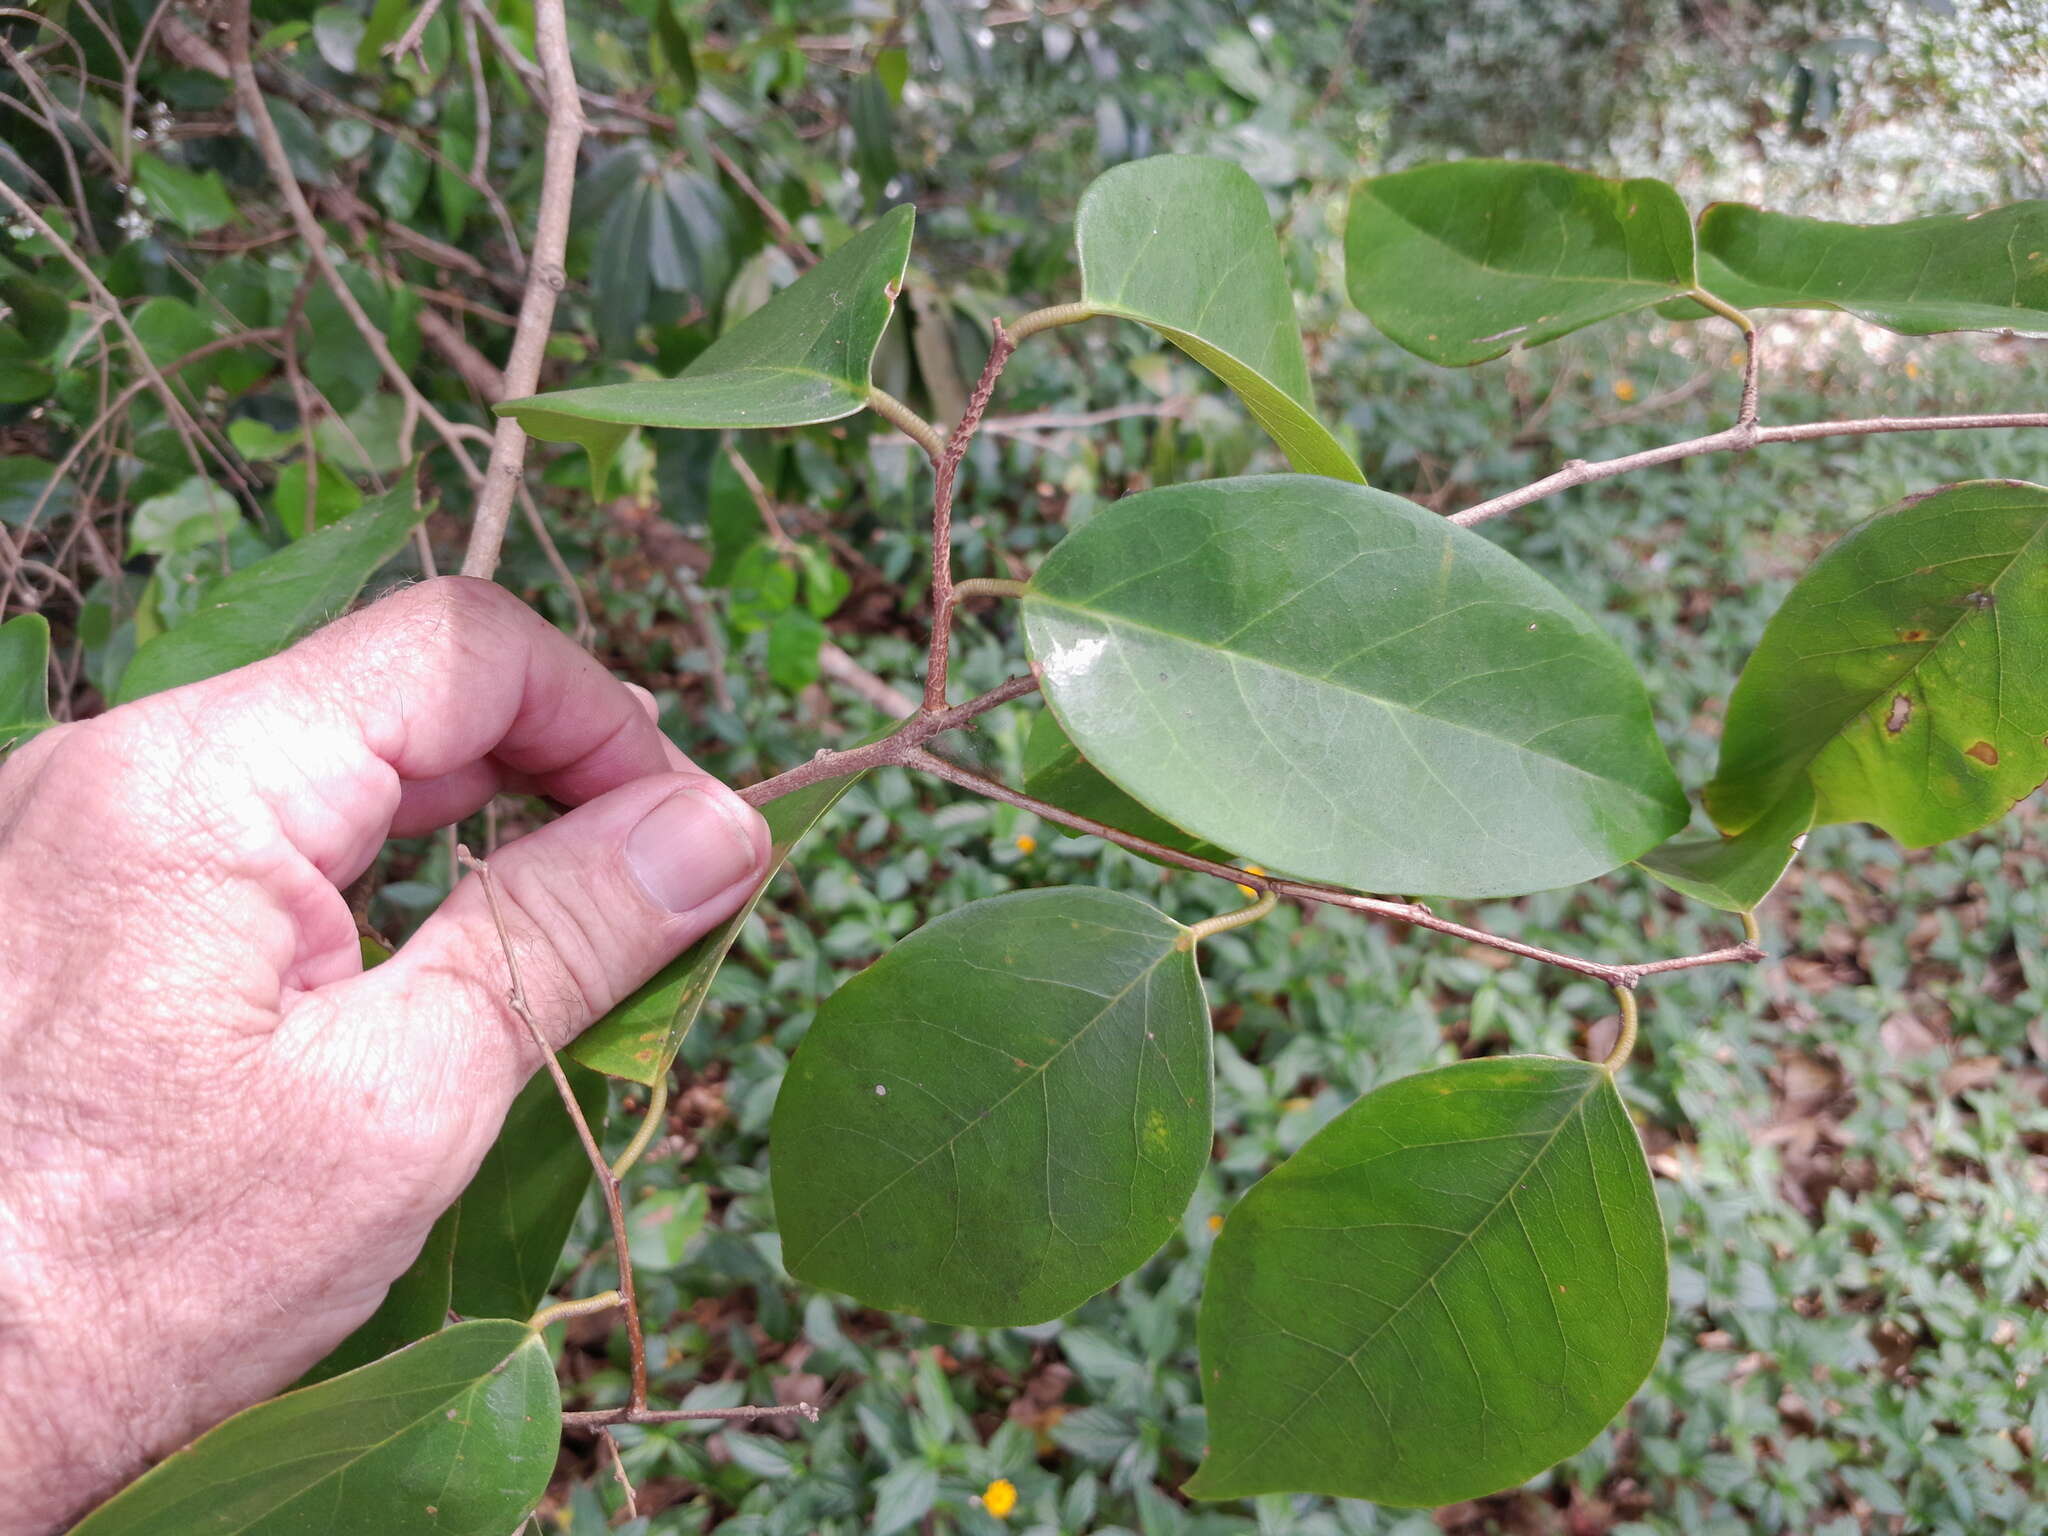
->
[{"left": 1706, "top": 479, "right": 2048, "bottom": 848}]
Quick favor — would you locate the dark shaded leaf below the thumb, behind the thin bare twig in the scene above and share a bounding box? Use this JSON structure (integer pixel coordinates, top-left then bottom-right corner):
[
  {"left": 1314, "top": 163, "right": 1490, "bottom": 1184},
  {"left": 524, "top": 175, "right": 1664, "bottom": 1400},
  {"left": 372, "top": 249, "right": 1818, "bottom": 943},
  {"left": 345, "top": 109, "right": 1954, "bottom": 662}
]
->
[{"left": 449, "top": 1063, "right": 610, "bottom": 1317}]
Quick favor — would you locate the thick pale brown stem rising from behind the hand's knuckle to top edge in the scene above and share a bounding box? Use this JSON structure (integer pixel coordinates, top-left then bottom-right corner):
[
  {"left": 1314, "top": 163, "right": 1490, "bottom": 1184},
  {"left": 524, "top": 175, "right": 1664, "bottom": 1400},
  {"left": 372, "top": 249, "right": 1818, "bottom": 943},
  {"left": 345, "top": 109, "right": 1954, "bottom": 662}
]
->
[{"left": 463, "top": 0, "right": 584, "bottom": 580}]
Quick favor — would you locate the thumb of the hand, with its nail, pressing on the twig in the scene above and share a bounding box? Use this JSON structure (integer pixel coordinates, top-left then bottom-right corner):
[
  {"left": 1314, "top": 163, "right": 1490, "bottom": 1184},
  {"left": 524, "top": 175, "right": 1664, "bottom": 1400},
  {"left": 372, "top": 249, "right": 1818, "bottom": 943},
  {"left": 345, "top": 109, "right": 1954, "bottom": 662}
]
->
[{"left": 362, "top": 772, "right": 770, "bottom": 1085}]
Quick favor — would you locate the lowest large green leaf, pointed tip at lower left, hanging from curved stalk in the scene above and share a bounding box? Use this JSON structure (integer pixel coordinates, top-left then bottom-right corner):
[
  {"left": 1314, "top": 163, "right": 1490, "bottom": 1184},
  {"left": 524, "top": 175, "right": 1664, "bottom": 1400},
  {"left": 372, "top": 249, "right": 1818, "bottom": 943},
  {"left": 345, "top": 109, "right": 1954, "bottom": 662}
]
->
[{"left": 1186, "top": 1057, "right": 1665, "bottom": 1505}]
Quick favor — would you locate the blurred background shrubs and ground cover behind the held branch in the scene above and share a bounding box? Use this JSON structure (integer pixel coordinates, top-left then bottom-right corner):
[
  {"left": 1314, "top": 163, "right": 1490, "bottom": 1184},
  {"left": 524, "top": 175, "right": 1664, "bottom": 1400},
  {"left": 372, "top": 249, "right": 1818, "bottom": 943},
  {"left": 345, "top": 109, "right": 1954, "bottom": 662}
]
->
[{"left": 0, "top": 0, "right": 2048, "bottom": 1536}]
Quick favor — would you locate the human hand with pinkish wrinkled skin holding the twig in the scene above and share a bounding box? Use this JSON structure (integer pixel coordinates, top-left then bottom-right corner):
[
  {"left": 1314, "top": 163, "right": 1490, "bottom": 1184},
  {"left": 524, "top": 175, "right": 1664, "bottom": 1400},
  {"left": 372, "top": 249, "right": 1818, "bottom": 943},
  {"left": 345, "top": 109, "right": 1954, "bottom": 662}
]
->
[{"left": 0, "top": 580, "right": 768, "bottom": 1534}]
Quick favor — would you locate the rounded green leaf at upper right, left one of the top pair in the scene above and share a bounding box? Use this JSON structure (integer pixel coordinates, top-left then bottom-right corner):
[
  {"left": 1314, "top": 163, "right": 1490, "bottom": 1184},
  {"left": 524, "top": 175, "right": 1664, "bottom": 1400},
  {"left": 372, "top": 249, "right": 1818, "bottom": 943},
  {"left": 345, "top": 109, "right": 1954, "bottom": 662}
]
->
[{"left": 1343, "top": 160, "right": 1698, "bottom": 367}]
